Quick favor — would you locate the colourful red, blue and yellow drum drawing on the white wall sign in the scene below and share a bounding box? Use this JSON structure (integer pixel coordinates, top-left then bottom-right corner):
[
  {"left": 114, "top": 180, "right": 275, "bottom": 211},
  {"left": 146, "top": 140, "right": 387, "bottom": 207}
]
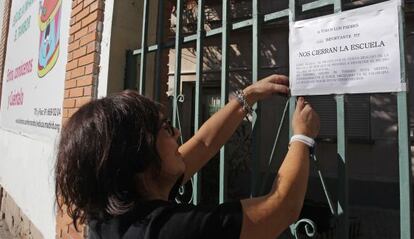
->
[{"left": 37, "top": 0, "right": 62, "bottom": 78}]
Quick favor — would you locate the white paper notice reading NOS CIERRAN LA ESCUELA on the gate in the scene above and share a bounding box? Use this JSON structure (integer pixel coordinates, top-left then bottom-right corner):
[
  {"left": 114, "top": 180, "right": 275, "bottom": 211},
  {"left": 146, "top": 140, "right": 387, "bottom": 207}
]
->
[{"left": 289, "top": 1, "right": 405, "bottom": 95}]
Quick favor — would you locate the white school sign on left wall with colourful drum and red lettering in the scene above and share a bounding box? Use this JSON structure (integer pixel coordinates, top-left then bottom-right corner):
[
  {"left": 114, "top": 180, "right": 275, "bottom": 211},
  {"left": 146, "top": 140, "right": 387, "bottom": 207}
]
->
[{"left": 0, "top": 0, "right": 71, "bottom": 139}]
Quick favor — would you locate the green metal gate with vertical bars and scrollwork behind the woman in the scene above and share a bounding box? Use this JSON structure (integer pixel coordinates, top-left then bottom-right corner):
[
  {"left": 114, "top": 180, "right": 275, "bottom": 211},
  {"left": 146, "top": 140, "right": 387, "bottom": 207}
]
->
[{"left": 127, "top": 0, "right": 412, "bottom": 239}]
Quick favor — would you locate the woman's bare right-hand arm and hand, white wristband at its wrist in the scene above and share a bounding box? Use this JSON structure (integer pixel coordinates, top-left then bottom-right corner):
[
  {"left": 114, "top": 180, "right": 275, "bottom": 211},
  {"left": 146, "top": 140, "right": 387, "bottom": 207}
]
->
[{"left": 240, "top": 97, "right": 319, "bottom": 239}]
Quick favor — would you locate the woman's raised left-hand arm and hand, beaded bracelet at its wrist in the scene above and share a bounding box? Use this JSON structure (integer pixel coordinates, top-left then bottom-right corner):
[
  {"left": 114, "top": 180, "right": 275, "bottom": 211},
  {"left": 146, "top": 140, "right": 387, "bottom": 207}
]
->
[{"left": 178, "top": 75, "right": 289, "bottom": 182}]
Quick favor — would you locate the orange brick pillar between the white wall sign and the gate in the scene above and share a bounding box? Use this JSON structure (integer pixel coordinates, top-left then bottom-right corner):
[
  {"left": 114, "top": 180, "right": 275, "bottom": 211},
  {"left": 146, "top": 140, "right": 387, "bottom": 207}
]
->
[{"left": 56, "top": 0, "right": 104, "bottom": 238}]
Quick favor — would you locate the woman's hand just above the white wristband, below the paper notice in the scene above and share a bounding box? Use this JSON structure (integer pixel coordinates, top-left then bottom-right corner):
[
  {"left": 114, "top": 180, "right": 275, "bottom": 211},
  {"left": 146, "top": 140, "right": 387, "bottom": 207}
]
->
[{"left": 292, "top": 97, "right": 320, "bottom": 138}]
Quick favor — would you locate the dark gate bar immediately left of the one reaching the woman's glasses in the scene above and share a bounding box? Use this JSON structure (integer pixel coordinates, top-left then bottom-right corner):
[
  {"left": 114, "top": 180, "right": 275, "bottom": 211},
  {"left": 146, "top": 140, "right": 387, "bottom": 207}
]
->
[{"left": 154, "top": 0, "right": 164, "bottom": 101}]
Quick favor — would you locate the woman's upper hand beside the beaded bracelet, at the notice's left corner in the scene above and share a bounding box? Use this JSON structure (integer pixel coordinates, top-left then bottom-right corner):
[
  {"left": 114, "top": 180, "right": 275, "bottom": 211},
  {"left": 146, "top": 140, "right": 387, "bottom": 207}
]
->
[{"left": 243, "top": 75, "right": 289, "bottom": 106}]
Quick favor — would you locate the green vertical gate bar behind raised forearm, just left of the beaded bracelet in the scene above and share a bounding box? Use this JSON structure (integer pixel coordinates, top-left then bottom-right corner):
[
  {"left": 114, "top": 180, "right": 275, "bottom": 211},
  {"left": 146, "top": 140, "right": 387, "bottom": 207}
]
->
[{"left": 219, "top": 0, "right": 229, "bottom": 203}]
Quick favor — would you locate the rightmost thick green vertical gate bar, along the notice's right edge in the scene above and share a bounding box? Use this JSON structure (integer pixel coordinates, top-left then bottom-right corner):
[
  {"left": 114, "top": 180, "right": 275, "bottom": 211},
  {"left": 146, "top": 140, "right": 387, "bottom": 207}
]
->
[{"left": 397, "top": 1, "right": 412, "bottom": 239}]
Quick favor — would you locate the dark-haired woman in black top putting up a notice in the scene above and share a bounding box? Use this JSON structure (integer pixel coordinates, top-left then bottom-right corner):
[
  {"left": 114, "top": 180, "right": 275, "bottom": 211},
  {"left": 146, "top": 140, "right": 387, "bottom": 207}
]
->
[{"left": 56, "top": 75, "right": 319, "bottom": 239}]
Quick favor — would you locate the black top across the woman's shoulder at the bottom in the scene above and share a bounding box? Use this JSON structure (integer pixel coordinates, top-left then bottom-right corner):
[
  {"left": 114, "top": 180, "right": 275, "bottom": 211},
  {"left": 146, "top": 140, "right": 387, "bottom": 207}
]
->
[{"left": 89, "top": 200, "right": 242, "bottom": 239}]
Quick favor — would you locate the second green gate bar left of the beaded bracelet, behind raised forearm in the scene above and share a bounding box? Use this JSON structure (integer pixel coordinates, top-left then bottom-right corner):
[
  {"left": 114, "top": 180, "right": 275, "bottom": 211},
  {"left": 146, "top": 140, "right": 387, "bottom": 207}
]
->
[{"left": 193, "top": 0, "right": 205, "bottom": 205}]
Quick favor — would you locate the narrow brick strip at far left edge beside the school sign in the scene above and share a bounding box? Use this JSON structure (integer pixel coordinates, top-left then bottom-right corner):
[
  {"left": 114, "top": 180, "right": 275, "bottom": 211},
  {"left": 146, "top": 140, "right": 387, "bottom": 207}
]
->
[{"left": 0, "top": 0, "right": 11, "bottom": 101}]
